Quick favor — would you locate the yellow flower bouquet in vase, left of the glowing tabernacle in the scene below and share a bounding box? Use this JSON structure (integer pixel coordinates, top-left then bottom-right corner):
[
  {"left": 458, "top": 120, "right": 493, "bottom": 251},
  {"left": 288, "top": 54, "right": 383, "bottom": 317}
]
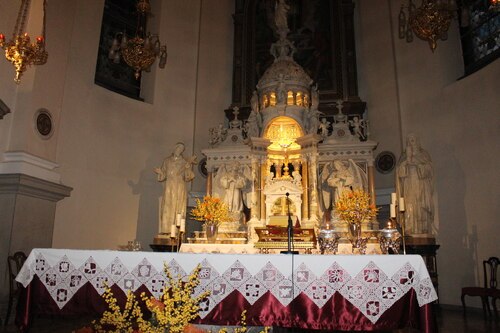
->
[{"left": 191, "top": 195, "right": 231, "bottom": 225}]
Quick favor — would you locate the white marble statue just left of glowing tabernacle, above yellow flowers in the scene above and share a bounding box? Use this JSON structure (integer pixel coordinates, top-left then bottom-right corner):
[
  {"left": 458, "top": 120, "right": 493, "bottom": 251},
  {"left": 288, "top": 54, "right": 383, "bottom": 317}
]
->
[{"left": 219, "top": 162, "right": 247, "bottom": 213}]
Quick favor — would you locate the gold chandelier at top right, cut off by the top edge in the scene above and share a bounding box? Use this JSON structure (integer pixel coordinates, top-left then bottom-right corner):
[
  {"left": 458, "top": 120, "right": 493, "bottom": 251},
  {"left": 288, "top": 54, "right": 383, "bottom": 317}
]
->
[{"left": 399, "top": 0, "right": 457, "bottom": 52}]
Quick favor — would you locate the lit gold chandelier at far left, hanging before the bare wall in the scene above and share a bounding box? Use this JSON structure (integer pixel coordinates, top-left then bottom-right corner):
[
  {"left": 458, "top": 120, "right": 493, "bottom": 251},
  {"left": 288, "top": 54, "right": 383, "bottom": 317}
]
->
[{"left": 0, "top": 0, "right": 48, "bottom": 84}]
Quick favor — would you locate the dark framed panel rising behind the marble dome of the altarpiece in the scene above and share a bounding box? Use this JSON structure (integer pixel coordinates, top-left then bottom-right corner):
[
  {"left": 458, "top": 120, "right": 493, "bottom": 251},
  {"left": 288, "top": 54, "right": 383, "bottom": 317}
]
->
[{"left": 226, "top": 0, "right": 366, "bottom": 119}]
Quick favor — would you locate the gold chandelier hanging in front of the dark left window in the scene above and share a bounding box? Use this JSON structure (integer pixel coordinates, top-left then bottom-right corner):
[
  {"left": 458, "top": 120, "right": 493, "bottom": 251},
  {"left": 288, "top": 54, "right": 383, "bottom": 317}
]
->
[{"left": 108, "top": 0, "right": 167, "bottom": 80}]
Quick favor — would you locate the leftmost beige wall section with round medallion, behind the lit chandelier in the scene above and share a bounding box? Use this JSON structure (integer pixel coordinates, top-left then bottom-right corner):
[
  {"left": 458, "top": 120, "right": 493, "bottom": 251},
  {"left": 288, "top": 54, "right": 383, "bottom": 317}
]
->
[{"left": 0, "top": 0, "right": 74, "bottom": 161}]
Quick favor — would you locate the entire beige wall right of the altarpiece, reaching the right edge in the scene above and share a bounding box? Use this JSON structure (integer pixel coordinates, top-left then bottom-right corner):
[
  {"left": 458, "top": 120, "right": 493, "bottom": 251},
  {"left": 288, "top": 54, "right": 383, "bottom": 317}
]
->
[{"left": 357, "top": 0, "right": 500, "bottom": 306}]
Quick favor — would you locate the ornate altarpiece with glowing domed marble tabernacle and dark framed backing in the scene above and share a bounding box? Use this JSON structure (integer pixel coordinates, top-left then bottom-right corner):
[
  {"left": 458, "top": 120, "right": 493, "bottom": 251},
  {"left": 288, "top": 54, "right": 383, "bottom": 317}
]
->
[{"left": 192, "top": 0, "right": 378, "bottom": 243}]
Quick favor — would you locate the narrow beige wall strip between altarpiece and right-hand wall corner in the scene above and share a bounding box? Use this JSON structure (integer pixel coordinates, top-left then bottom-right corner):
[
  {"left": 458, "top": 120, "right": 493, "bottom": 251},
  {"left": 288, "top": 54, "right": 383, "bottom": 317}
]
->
[{"left": 355, "top": 1, "right": 401, "bottom": 189}]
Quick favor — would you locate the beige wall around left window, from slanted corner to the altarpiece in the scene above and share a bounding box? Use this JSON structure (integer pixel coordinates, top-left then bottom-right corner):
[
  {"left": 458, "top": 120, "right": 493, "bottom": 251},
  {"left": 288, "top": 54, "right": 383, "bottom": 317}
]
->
[{"left": 53, "top": 0, "right": 233, "bottom": 250}]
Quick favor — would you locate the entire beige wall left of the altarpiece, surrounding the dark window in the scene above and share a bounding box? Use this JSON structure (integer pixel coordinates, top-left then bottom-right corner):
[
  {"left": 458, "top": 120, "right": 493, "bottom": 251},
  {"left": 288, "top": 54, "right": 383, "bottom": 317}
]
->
[{"left": 0, "top": 0, "right": 234, "bottom": 248}]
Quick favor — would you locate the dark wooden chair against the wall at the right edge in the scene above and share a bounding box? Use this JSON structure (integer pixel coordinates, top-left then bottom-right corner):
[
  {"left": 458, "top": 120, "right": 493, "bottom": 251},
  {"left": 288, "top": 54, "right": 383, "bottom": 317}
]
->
[{"left": 461, "top": 257, "right": 500, "bottom": 315}]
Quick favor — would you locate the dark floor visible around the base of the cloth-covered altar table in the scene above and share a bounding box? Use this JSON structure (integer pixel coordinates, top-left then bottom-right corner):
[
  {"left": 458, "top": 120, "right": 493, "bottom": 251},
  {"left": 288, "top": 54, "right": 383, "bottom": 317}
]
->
[{"left": 0, "top": 306, "right": 500, "bottom": 333}]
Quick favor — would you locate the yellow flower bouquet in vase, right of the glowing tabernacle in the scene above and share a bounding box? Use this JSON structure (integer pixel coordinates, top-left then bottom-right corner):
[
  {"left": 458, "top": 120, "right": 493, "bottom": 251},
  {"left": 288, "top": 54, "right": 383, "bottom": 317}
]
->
[{"left": 335, "top": 189, "right": 378, "bottom": 224}]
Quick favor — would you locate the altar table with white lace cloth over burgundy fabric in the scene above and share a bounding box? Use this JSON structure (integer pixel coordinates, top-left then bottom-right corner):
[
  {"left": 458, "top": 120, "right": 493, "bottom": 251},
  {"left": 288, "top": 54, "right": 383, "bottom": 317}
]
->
[{"left": 16, "top": 249, "right": 437, "bottom": 332}]
